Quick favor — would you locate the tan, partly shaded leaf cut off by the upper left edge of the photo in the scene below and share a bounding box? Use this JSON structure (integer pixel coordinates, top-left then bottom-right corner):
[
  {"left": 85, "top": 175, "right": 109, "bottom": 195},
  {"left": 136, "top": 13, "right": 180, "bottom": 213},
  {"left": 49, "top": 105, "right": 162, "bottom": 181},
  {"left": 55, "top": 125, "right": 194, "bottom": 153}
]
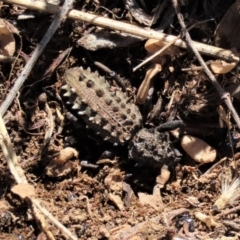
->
[{"left": 0, "top": 19, "right": 16, "bottom": 57}]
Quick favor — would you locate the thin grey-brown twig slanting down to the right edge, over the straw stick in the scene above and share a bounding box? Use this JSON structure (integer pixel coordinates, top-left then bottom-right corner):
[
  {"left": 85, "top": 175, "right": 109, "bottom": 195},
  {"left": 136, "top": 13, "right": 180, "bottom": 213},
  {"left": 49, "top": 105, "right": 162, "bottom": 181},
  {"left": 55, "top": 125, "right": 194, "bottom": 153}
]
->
[{"left": 172, "top": 0, "right": 240, "bottom": 129}]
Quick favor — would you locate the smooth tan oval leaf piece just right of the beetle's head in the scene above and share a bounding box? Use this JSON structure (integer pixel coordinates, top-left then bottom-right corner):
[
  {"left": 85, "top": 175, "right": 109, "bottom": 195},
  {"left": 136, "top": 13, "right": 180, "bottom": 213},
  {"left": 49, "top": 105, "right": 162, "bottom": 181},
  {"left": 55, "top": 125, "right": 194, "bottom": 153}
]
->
[{"left": 181, "top": 135, "right": 217, "bottom": 163}]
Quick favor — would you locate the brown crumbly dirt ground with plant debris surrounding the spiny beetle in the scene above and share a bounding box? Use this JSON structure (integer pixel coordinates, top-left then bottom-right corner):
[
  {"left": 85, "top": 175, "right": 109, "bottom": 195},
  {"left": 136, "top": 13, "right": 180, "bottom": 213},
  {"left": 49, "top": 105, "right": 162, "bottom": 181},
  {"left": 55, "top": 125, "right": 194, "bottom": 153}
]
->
[{"left": 0, "top": 0, "right": 240, "bottom": 240}]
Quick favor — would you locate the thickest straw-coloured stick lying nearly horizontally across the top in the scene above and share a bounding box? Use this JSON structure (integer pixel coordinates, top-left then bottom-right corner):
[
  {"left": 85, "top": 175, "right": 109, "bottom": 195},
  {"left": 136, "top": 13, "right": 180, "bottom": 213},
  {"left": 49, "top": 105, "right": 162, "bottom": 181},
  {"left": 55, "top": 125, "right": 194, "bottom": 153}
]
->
[{"left": 3, "top": 0, "right": 239, "bottom": 61}]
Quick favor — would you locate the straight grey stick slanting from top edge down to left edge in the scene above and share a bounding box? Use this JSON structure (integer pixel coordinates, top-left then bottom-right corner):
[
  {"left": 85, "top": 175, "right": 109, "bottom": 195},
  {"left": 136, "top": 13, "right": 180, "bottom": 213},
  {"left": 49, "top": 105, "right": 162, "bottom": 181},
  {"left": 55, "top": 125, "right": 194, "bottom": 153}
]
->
[{"left": 0, "top": 0, "right": 74, "bottom": 116}]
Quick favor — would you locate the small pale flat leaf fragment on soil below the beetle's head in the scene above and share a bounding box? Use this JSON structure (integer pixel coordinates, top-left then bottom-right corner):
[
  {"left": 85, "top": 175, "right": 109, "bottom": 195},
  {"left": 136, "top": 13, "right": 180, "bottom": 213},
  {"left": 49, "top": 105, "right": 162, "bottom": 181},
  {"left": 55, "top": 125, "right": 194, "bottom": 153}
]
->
[{"left": 138, "top": 192, "right": 163, "bottom": 211}]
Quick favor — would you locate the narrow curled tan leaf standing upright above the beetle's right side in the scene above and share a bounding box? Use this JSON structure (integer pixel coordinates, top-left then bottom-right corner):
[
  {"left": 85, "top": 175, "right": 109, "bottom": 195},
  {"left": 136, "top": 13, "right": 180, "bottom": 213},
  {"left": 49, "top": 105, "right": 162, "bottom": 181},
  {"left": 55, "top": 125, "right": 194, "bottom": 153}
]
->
[{"left": 136, "top": 63, "right": 162, "bottom": 104}]
